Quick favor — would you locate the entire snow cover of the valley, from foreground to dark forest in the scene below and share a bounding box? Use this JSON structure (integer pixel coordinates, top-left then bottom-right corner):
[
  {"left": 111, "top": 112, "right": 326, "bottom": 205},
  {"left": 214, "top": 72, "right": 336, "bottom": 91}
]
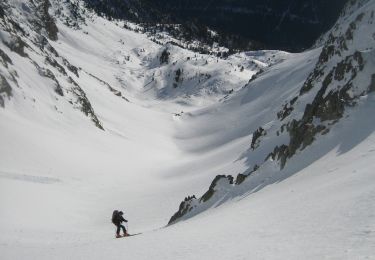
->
[{"left": 0, "top": 0, "right": 375, "bottom": 259}]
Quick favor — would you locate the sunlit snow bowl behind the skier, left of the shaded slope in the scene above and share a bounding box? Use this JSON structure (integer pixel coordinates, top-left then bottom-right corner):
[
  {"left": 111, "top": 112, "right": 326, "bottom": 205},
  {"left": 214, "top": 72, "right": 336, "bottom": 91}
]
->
[{"left": 0, "top": 1, "right": 274, "bottom": 244}]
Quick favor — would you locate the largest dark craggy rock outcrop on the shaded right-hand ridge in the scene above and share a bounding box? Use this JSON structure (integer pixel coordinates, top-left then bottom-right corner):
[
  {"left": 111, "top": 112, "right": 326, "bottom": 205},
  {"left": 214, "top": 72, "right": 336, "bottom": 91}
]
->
[{"left": 270, "top": 50, "right": 364, "bottom": 168}]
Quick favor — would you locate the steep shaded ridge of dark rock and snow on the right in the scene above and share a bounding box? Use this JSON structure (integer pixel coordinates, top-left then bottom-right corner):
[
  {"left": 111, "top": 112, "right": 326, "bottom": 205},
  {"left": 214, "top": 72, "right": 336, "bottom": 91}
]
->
[{"left": 169, "top": 1, "right": 375, "bottom": 224}]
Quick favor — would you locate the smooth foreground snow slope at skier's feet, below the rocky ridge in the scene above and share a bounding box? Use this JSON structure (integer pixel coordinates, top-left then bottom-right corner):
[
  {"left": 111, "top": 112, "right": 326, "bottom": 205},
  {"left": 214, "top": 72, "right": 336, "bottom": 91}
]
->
[{"left": 2, "top": 129, "right": 375, "bottom": 259}]
